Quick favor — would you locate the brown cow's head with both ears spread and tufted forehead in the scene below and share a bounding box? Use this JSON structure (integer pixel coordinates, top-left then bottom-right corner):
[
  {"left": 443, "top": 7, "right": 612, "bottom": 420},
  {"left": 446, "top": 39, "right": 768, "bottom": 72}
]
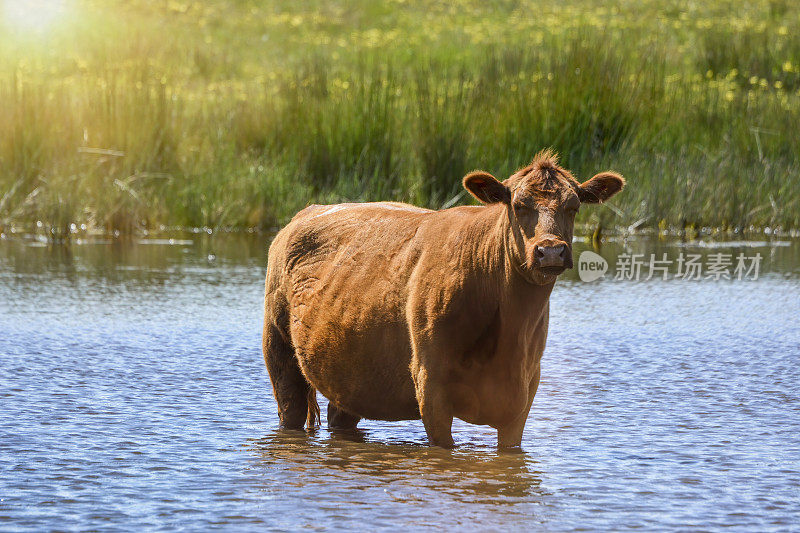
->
[{"left": 464, "top": 150, "right": 625, "bottom": 285}]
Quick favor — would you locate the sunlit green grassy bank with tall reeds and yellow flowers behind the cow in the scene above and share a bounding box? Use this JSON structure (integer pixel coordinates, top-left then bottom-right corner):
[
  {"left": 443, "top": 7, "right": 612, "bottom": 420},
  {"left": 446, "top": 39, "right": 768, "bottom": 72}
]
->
[{"left": 0, "top": 0, "right": 800, "bottom": 235}]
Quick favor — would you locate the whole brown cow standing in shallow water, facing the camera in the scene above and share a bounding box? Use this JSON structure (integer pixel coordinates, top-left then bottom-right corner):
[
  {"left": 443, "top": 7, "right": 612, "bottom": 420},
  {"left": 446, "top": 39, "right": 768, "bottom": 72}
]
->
[{"left": 263, "top": 151, "right": 625, "bottom": 447}]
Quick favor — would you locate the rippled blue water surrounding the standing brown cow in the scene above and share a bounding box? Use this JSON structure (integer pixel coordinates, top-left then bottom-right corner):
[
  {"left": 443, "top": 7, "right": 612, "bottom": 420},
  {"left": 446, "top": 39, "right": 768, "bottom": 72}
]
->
[{"left": 0, "top": 235, "right": 800, "bottom": 531}]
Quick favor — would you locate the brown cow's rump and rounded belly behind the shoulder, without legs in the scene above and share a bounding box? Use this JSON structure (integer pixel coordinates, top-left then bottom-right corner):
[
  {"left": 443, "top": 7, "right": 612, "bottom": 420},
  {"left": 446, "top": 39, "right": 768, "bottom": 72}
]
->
[{"left": 267, "top": 203, "right": 434, "bottom": 419}]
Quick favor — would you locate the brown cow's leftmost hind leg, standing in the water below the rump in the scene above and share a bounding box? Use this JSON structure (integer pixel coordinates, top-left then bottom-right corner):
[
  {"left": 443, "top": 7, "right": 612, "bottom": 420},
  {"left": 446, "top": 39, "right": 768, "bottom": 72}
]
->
[{"left": 263, "top": 324, "right": 313, "bottom": 429}]
